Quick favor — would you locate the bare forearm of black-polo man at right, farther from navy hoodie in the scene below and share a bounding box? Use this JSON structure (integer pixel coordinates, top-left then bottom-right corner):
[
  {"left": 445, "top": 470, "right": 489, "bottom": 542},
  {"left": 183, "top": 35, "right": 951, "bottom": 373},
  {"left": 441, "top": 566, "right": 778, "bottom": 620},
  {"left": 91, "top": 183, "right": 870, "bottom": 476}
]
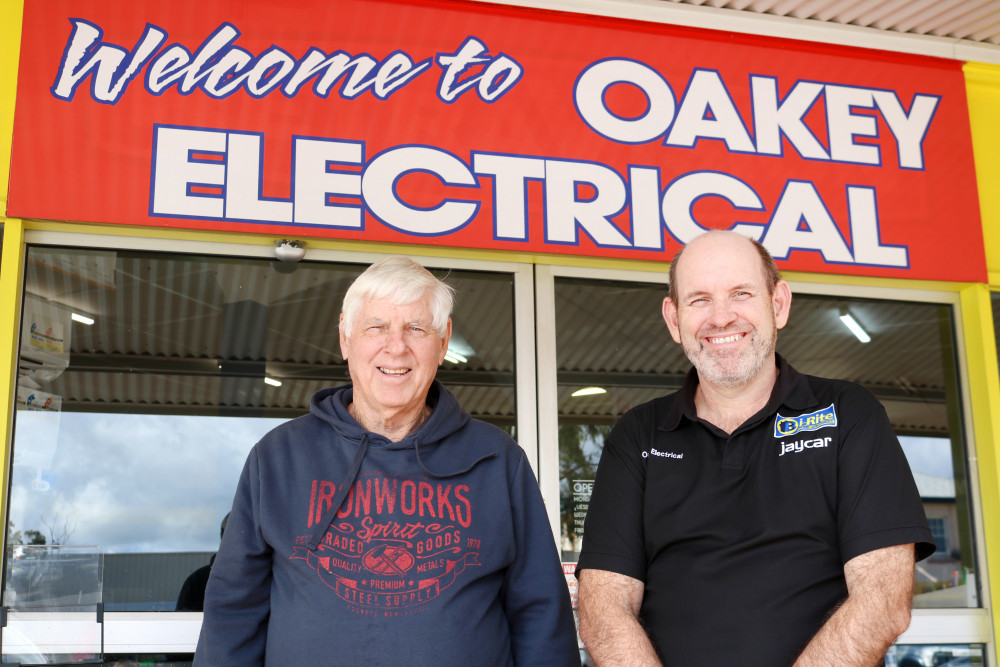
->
[{"left": 794, "top": 544, "right": 914, "bottom": 667}]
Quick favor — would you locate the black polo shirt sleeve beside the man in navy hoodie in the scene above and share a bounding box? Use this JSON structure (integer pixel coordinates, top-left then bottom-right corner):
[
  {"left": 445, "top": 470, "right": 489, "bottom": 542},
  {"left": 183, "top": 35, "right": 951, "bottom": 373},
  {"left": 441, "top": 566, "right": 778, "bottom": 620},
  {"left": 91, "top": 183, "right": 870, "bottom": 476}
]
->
[{"left": 576, "top": 404, "right": 655, "bottom": 581}]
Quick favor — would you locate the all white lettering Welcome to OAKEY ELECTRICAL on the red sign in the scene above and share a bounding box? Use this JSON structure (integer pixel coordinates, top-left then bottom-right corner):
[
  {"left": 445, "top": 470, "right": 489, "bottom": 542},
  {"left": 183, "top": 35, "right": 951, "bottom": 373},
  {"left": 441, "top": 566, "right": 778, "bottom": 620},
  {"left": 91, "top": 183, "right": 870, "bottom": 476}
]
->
[{"left": 50, "top": 19, "right": 941, "bottom": 269}]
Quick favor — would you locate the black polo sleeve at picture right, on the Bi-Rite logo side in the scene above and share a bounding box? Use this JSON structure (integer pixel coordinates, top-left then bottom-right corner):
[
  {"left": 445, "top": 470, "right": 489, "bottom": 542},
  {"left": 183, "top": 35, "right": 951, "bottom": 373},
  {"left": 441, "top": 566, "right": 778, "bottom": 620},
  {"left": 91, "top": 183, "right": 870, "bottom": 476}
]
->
[{"left": 837, "top": 392, "right": 935, "bottom": 563}]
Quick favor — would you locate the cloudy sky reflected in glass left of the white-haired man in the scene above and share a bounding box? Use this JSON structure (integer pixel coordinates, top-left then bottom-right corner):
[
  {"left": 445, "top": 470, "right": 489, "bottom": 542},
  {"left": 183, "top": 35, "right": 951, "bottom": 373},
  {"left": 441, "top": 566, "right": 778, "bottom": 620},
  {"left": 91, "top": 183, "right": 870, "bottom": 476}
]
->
[{"left": 10, "top": 411, "right": 285, "bottom": 553}]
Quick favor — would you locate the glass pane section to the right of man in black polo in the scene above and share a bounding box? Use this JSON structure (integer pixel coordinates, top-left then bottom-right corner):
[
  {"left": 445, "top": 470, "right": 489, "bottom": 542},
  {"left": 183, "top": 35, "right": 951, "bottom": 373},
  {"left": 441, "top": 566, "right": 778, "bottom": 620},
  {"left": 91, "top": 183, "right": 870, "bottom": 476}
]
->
[{"left": 778, "top": 295, "right": 979, "bottom": 608}]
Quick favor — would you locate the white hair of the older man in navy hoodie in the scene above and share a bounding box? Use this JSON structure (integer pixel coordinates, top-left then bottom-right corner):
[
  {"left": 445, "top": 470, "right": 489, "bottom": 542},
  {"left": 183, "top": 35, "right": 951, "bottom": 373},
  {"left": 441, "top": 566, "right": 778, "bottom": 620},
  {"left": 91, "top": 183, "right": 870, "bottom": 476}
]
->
[{"left": 340, "top": 255, "right": 455, "bottom": 338}]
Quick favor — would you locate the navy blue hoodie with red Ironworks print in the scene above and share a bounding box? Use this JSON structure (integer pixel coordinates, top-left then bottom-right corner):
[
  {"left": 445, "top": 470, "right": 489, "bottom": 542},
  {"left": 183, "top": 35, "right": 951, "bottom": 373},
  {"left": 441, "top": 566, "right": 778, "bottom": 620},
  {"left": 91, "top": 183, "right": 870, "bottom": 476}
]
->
[{"left": 194, "top": 381, "right": 580, "bottom": 667}]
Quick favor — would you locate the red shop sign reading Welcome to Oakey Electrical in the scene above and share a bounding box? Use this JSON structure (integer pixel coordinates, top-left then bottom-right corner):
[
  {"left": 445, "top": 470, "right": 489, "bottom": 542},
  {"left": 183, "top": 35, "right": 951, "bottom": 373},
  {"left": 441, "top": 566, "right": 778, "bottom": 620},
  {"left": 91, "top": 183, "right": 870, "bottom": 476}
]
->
[{"left": 8, "top": 0, "right": 986, "bottom": 281}]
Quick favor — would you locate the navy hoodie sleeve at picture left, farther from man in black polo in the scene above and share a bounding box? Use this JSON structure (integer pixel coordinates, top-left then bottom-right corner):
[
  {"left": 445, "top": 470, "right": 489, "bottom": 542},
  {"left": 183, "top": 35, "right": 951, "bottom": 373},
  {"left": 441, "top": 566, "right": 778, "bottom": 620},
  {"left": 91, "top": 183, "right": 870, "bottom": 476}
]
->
[{"left": 193, "top": 448, "right": 272, "bottom": 667}]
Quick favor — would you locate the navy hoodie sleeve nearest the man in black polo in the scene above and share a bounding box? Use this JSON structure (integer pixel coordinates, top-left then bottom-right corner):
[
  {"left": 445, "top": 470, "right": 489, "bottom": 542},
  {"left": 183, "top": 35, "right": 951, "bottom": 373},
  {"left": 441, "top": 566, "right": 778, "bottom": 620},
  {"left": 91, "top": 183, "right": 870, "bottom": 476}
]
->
[{"left": 502, "top": 453, "right": 580, "bottom": 667}]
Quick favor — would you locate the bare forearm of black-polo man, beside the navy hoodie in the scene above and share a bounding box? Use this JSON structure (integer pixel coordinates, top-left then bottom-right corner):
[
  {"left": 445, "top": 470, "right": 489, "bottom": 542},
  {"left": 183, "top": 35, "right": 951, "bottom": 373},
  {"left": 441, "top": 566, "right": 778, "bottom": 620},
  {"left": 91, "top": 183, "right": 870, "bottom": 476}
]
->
[{"left": 579, "top": 569, "right": 660, "bottom": 667}]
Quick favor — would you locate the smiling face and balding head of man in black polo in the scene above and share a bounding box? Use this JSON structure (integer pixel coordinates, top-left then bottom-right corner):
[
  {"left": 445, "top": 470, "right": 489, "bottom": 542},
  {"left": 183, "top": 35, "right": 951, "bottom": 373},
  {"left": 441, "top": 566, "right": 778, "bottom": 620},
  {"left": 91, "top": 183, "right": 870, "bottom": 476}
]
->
[{"left": 663, "top": 233, "right": 790, "bottom": 387}]
